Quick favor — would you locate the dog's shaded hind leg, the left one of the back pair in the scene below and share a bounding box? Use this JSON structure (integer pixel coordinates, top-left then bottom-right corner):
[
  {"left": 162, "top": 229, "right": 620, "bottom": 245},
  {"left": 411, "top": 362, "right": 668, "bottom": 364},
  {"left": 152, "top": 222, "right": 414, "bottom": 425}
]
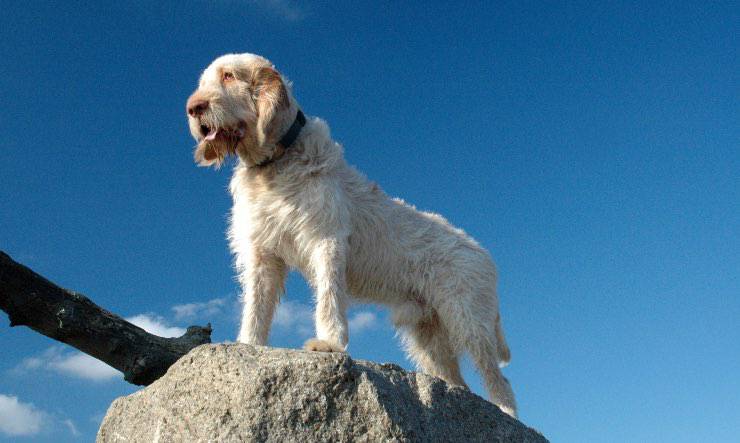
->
[{"left": 401, "top": 313, "right": 467, "bottom": 388}]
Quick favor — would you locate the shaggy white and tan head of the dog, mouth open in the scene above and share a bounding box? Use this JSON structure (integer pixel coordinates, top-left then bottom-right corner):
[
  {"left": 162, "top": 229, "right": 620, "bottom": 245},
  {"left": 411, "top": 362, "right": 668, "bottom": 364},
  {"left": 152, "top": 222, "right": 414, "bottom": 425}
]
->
[{"left": 186, "top": 54, "right": 297, "bottom": 166}]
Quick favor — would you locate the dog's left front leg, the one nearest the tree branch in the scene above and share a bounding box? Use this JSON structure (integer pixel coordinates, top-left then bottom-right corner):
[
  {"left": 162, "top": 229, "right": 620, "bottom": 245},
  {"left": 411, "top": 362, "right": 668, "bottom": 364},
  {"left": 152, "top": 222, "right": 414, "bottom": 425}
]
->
[{"left": 237, "top": 248, "right": 287, "bottom": 345}]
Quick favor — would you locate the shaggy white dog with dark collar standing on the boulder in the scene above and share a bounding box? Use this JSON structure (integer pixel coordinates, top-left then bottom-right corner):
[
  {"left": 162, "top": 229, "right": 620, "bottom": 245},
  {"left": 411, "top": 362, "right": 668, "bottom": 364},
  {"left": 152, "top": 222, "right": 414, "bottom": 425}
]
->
[{"left": 187, "top": 54, "right": 516, "bottom": 416}]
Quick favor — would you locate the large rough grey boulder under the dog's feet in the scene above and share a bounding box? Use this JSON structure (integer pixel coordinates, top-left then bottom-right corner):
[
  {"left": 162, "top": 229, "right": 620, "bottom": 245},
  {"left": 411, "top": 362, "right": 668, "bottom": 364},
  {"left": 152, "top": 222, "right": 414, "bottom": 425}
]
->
[{"left": 97, "top": 344, "right": 547, "bottom": 442}]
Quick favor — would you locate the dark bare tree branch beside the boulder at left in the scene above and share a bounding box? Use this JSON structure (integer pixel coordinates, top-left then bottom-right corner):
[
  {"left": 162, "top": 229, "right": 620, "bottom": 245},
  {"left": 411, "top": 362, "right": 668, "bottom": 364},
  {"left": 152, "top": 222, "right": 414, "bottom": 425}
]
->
[{"left": 0, "top": 251, "right": 211, "bottom": 385}]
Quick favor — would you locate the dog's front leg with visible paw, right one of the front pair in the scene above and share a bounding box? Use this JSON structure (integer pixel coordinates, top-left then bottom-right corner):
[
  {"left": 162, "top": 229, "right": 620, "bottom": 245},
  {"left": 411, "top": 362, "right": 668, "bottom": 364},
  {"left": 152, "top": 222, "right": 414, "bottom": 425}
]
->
[{"left": 304, "top": 238, "right": 349, "bottom": 352}]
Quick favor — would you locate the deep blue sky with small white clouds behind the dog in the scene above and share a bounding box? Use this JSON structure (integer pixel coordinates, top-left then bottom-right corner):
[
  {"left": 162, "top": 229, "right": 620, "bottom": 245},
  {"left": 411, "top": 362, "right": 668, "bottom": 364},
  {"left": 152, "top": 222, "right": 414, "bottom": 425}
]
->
[{"left": 0, "top": 0, "right": 740, "bottom": 442}]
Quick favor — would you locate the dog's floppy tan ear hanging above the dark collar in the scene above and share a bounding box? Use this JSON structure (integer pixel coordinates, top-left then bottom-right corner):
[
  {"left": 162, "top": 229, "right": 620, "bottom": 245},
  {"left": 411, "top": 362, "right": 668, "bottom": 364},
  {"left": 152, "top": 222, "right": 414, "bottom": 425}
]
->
[{"left": 252, "top": 67, "right": 290, "bottom": 146}]
